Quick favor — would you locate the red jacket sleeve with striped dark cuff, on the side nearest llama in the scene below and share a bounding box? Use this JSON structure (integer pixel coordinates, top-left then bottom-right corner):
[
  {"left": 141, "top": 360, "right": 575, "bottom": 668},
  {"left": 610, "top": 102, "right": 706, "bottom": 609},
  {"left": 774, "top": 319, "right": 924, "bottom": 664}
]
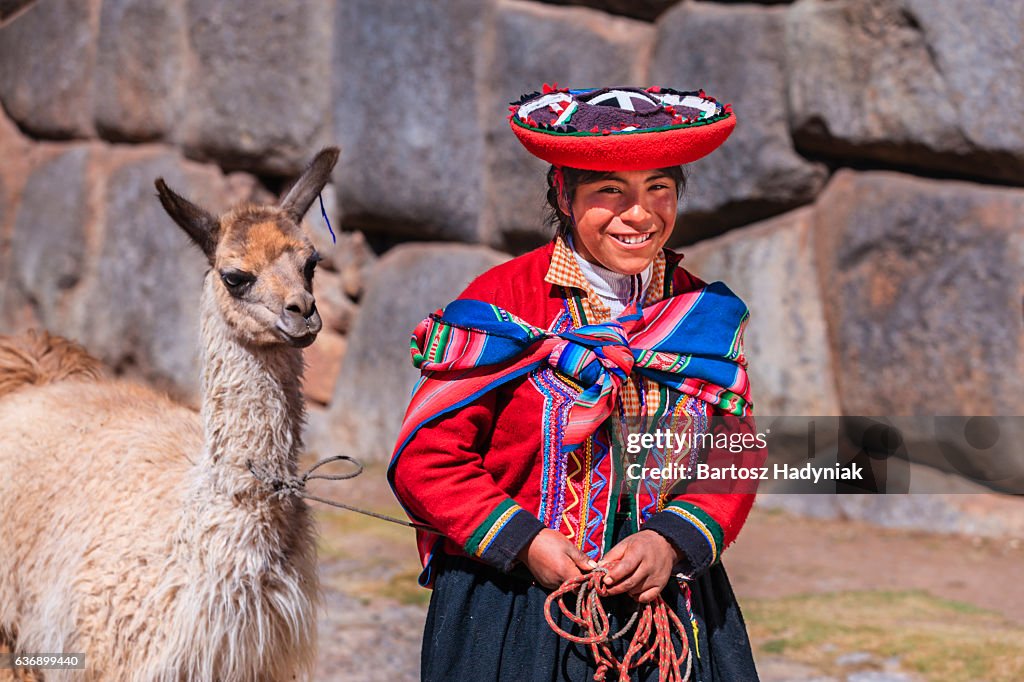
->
[{"left": 391, "top": 374, "right": 544, "bottom": 571}]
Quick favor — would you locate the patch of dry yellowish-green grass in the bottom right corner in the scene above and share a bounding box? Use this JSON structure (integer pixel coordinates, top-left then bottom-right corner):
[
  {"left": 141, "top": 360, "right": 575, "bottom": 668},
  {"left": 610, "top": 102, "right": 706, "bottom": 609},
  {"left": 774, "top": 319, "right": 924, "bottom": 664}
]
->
[{"left": 743, "top": 591, "right": 1024, "bottom": 682}]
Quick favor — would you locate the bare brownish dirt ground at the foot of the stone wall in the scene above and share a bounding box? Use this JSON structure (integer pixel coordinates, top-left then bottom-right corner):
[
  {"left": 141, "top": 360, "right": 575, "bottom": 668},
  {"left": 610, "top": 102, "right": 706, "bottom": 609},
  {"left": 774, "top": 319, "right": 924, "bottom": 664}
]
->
[{"left": 305, "top": 468, "right": 1024, "bottom": 682}]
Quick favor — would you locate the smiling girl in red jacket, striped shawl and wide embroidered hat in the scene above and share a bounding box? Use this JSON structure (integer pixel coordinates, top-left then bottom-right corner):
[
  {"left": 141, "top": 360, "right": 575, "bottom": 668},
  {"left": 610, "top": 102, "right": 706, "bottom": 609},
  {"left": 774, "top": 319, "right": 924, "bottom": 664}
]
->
[{"left": 388, "top": 86, "right": 758, "bottom": 682}]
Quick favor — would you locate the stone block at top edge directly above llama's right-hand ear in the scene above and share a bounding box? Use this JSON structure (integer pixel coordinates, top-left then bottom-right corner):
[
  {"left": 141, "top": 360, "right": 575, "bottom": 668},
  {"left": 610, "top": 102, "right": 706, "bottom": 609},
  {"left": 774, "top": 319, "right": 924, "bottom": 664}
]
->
[{"left": 178, "top": 0, "right": 331, "bottom": 176}]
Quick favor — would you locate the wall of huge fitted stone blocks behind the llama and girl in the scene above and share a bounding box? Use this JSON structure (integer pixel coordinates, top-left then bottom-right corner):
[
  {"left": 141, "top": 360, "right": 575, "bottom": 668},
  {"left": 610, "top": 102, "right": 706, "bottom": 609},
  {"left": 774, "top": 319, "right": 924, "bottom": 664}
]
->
[{"left": 0, "top": 0, "right": 1024, "bottom": 483}]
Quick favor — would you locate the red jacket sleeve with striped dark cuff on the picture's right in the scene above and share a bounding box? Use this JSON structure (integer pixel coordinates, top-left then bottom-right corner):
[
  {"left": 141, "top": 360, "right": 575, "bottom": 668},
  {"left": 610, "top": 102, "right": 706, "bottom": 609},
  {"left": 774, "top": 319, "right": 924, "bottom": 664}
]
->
[{"left": 643, "top": 410, "right": 767, "bottom": 578}]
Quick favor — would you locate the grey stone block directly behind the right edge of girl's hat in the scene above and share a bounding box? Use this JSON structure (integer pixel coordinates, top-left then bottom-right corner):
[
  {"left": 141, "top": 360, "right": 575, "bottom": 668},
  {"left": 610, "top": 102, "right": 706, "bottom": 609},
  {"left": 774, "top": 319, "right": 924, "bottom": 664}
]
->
[{"left": 650, "top": 3, "right": 826, "bottom": 238}]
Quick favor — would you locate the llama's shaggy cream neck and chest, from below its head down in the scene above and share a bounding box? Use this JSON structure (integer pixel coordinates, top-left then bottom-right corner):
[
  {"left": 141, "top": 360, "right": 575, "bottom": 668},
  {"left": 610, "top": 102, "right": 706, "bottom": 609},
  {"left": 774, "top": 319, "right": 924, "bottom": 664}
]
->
[{"left": 152, "top": 278, "right": 319, "bottom": 680}]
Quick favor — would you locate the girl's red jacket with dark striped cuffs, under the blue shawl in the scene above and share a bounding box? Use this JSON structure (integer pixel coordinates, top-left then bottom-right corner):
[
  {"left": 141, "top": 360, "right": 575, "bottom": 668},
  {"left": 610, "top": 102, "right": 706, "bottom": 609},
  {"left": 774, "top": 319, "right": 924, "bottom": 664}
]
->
[{"left": 390, "top": 242, "right": 754, "bottom": 584}]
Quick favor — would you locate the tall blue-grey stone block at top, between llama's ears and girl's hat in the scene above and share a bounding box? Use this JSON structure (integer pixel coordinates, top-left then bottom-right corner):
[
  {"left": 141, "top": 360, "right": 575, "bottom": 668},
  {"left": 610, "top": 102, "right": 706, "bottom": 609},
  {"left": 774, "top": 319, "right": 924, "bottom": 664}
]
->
[{"left": 334, "top": 0, "right": 490, "bottom": 242}]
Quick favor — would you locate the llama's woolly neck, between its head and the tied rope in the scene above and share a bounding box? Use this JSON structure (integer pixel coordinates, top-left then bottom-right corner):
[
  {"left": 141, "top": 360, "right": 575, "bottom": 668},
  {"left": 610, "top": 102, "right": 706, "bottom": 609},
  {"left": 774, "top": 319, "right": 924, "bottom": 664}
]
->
[{"left": 201, "top": 280, "right": 305, "bottom": 485}]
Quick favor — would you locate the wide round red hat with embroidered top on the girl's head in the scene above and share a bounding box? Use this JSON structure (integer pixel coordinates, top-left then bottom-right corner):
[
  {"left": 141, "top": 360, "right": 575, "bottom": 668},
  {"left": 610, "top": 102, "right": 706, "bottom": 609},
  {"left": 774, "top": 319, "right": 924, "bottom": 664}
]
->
[{"left": 509, "top": 84, "right": 736, "bottom": 171}]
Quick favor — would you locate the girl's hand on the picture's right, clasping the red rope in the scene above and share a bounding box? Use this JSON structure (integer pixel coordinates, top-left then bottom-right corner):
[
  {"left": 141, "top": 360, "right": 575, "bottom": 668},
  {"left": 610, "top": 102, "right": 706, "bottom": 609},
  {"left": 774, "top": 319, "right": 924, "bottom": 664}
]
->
[{"left": 598, "top": 530, "right": 682, "bottom": 604}]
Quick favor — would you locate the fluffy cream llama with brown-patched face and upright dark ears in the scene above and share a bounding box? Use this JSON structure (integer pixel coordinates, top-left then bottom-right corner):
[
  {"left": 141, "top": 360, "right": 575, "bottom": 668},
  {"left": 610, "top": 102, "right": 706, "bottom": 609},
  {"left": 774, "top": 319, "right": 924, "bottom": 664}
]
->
[{"left": 0, "top": 147, "right": 338, "bottom": 682}]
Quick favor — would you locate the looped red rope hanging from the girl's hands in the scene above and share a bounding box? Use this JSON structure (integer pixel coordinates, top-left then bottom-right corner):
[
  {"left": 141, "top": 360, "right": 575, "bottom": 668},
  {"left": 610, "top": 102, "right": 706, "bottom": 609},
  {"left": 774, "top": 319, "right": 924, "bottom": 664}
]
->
[{"left": 544, "top": 568, "right": 692, "bottom": 682}]
